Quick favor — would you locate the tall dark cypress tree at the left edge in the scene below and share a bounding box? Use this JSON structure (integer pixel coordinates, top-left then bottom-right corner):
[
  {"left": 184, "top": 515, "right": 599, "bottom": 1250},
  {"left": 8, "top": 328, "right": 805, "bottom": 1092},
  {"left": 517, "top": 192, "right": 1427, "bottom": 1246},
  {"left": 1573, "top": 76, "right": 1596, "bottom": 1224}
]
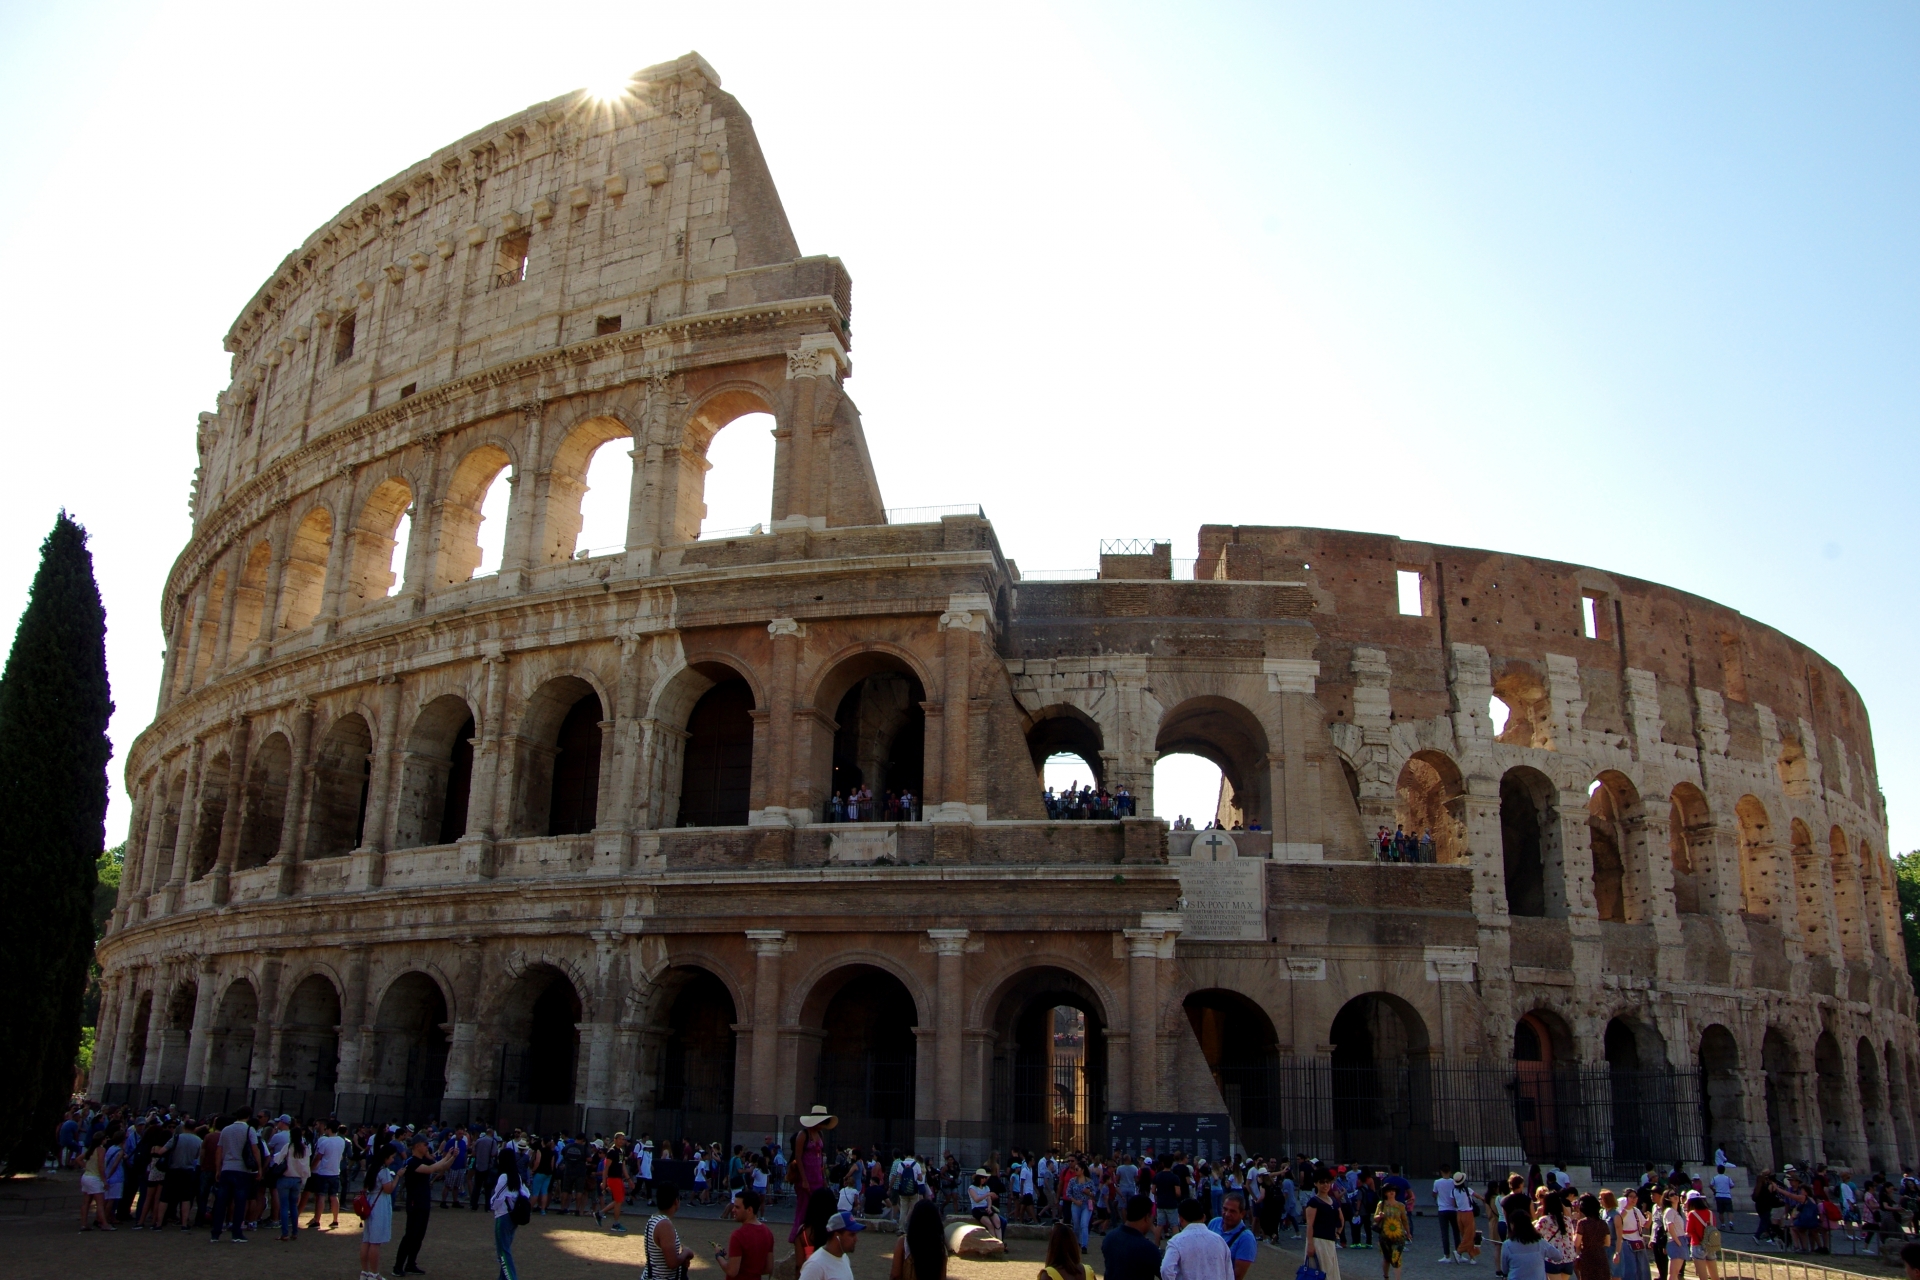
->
[{"left": 0, "top": 510, "right": 113, "bottom": 1173}]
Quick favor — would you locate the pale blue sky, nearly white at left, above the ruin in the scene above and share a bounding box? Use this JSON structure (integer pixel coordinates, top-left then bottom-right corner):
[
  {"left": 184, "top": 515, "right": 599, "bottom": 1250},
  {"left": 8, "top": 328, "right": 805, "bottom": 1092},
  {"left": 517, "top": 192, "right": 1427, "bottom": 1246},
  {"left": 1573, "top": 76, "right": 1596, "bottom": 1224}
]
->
[{"left": 0, "top": 2, "right": 1920, "bottom": 850}]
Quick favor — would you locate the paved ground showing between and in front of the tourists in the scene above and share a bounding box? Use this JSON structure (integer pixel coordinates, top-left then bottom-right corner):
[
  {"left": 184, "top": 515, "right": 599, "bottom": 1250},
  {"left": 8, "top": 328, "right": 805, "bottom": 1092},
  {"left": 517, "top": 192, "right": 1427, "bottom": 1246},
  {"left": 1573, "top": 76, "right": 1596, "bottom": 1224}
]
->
[{"left": 0, "top": 1182, "right": 1899, "bottom": 1280}]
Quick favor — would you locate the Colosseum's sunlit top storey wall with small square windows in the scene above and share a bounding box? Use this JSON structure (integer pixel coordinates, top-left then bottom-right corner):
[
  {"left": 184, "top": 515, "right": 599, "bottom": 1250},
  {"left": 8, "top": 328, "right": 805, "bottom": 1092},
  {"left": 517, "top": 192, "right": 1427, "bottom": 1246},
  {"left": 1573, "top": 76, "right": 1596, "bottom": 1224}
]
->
[{"left": 194, "top": 54, "right": 814, "bottom": 522}]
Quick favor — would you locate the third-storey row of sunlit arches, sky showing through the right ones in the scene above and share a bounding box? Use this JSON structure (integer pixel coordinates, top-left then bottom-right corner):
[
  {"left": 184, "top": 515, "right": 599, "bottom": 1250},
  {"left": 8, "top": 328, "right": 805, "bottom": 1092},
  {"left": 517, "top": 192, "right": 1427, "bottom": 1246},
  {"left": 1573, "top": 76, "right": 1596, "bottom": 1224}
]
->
[{"left": 163, "top": 408, "right": 772, "bottom": 699}]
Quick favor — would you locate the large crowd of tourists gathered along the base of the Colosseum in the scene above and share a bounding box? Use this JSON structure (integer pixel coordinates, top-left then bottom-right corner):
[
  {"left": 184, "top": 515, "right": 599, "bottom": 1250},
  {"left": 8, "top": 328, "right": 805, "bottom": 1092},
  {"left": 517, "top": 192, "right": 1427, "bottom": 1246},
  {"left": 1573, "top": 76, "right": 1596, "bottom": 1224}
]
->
[{"left": 56, "top": 1103, "right": 1920, "bottom": 1280}]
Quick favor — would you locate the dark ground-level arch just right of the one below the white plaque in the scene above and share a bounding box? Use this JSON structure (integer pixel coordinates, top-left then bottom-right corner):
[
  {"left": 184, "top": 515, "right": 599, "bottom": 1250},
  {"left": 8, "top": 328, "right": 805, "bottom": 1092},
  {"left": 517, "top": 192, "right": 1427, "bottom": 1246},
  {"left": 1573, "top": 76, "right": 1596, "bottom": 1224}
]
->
[{"left": 1327, "top": 992, "right": 1428, "bottom": 1169}]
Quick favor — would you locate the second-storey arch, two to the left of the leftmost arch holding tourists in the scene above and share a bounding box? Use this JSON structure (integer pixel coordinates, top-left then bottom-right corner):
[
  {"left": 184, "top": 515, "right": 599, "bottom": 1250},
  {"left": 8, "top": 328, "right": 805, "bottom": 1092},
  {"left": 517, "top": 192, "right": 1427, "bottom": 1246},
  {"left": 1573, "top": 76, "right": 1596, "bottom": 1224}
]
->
[{"left": 515, "top": 674, "right": 611, "bottom": 835}]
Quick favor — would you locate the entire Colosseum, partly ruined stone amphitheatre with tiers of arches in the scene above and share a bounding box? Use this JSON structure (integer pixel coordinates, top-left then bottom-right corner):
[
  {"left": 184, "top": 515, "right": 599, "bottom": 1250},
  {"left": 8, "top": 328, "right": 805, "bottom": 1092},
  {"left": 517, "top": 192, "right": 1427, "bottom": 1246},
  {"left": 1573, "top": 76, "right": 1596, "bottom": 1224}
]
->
[{"left": 94, "top": 54, "right": 1920, "bottom": 1171}]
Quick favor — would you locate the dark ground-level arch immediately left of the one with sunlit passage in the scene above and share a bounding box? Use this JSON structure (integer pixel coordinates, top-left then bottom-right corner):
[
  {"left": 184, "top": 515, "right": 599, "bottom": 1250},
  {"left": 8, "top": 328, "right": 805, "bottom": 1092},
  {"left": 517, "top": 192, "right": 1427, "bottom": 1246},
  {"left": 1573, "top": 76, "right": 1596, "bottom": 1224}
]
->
[{"left": 801, "top": 965, "right": 920, "bottom": 1148}]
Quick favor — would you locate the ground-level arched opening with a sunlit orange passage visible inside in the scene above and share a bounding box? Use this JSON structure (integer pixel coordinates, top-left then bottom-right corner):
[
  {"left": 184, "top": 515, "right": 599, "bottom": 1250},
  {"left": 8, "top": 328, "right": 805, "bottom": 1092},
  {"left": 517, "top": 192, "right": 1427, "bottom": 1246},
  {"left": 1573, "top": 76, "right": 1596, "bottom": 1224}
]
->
[{"left": 993, "top": 967, "right": 1108, "bottom": 1151}]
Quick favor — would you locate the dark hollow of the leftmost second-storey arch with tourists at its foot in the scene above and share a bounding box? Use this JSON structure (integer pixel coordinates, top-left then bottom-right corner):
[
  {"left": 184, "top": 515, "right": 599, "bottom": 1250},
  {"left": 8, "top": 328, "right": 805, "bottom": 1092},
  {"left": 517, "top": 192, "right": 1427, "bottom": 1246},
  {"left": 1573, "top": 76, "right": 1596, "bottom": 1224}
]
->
[{"left": 820, "top": 652, "right": 927, "bottom": 821}]
